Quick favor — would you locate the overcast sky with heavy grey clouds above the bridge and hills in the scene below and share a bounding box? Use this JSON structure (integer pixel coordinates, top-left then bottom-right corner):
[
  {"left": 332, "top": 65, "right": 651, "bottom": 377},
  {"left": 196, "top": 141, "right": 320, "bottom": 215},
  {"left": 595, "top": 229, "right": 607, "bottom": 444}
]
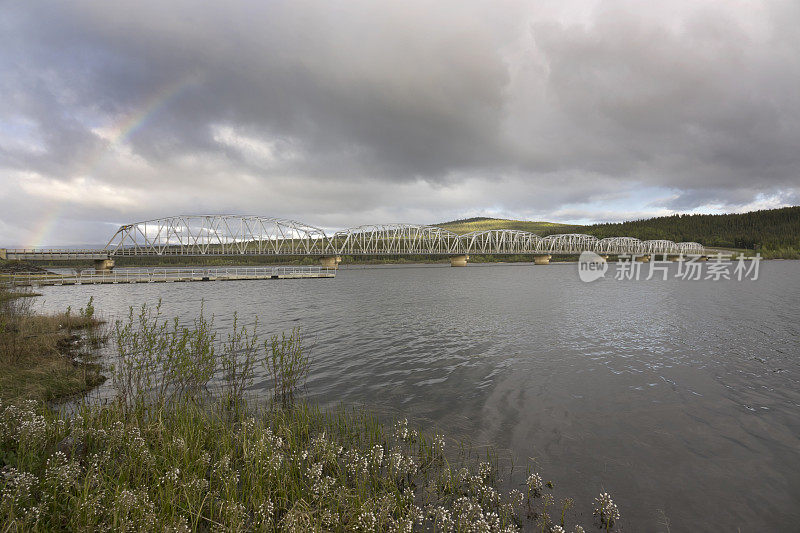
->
[{"left": 0, "top": 0, "right": 800, "bottom": 245}]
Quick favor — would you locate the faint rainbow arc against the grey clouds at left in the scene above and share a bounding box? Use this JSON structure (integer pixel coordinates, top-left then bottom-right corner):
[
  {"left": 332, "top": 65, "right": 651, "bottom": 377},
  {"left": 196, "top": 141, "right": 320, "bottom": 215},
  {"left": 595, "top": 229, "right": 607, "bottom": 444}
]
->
[{"left": 25, "top": 73, "right": 202, "bottom": 248}]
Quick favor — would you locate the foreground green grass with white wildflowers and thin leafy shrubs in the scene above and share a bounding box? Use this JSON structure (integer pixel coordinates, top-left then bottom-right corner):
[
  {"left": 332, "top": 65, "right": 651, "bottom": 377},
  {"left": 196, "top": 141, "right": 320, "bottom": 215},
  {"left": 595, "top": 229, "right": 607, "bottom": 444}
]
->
[{"left": 0, "top": 306, "right": 619, "bottom": 532}]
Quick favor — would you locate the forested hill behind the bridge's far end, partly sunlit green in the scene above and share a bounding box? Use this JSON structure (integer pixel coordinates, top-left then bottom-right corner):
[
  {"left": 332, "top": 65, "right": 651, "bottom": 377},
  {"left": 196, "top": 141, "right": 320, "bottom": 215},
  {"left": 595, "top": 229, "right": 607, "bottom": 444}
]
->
[{"left": 438, "top": 206, "right": 800, "bottom": 258}]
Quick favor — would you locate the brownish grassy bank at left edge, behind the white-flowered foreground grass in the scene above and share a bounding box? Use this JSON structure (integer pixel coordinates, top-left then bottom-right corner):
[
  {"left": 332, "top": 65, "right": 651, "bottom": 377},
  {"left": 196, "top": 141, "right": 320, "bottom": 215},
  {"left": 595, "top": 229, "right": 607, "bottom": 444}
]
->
[{"left": 0, "top": 288, "right": 105, "bottom": 401}]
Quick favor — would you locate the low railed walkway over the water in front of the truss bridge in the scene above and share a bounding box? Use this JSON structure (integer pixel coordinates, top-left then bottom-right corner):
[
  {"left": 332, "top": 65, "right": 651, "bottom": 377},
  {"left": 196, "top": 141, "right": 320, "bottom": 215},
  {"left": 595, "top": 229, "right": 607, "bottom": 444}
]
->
[{"left": 0, "top": 266, "right": 336, "bottom": 287}]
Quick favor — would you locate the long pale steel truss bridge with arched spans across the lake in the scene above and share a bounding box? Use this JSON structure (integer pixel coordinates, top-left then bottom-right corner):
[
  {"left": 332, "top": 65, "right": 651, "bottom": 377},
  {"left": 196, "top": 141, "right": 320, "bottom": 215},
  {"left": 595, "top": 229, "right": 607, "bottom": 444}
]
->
[{"left": 0, "top": 215, "right": 706, "bottom": 270}]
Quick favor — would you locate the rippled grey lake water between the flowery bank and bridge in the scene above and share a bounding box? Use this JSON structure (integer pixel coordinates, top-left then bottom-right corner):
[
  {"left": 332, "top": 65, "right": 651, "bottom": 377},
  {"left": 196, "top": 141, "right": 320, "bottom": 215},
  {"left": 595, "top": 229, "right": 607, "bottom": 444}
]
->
[{"left": 34, "top": 261, "right": 800, "bottom": 531}]
